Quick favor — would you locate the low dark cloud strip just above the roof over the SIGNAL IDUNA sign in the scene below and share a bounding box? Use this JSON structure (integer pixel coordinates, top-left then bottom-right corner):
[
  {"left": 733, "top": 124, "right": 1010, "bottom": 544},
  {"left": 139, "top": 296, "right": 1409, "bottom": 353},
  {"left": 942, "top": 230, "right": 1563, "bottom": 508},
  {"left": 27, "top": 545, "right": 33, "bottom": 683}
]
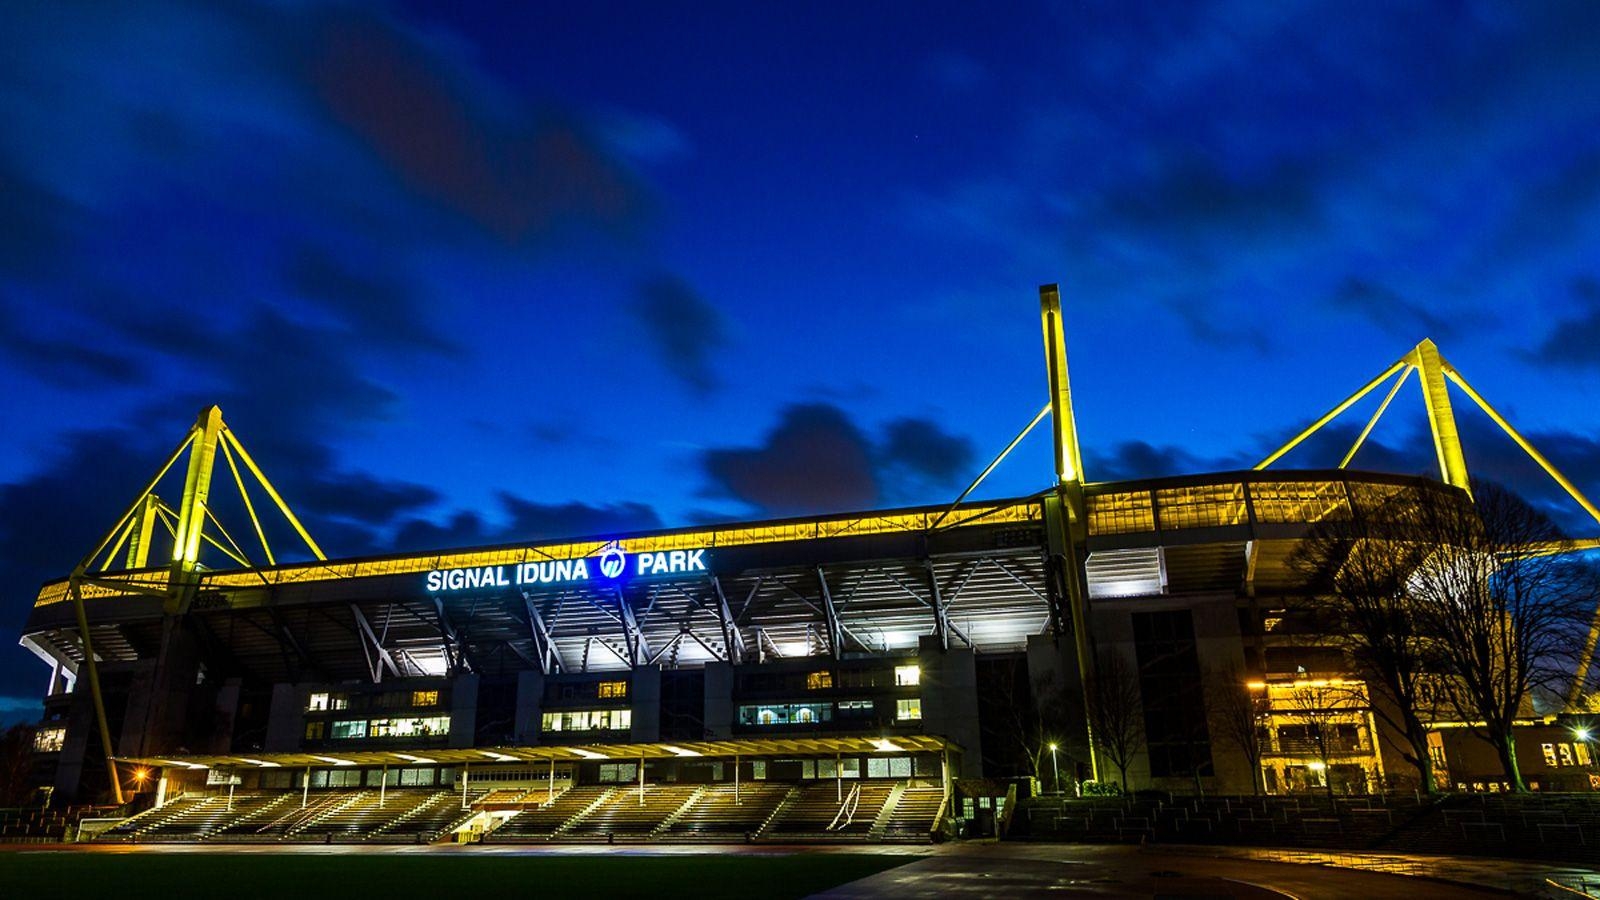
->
[{"left": 394, "top": 493, "right": 661, "bottom": 551}]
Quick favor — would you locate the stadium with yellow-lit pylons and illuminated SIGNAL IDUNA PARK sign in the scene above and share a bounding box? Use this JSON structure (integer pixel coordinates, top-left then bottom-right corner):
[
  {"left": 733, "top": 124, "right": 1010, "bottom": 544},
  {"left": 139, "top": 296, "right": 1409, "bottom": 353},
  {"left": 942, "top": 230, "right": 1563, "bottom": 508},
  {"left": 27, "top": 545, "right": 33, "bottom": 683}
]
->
[{"left": 22, "top": 287, "right": 1600, "bottom": 842}]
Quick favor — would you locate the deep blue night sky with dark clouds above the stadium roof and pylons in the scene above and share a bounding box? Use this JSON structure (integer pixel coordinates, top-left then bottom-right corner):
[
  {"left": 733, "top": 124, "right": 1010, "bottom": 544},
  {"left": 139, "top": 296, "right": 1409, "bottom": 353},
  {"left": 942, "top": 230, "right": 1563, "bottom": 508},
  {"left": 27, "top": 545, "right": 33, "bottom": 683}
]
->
[{"left": 0, "top": 0, "right": 1600, "bottom": 719}]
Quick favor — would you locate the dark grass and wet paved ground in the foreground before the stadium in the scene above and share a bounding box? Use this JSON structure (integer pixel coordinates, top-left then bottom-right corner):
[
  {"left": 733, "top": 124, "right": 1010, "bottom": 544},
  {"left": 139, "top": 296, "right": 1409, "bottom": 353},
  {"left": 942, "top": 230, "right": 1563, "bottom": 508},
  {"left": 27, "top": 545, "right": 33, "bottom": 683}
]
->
[{"left": 0, "top": 842, "right": 1557, "bottom": 900}]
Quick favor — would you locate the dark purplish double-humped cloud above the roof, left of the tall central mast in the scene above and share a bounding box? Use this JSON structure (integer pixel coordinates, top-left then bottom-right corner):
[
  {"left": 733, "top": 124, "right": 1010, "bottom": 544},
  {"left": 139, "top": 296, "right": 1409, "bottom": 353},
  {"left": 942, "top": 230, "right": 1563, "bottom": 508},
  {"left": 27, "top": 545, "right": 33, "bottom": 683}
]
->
[{"left": 701, "top": 404, "right": 976, "bottom": 516}]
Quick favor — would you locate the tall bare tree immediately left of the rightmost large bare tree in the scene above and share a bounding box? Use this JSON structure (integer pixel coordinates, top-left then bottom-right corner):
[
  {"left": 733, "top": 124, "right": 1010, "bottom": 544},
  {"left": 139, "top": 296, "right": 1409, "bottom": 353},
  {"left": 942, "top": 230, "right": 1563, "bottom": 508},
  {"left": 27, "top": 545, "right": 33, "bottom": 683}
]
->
[{"left": 1290, "top": 490, "right": 1459, "bottom": 793}]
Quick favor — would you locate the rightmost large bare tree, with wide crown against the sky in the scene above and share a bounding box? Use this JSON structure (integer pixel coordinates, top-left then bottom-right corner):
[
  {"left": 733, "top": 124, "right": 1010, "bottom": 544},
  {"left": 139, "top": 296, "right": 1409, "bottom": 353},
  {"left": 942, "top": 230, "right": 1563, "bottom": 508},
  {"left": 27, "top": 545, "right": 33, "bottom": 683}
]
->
[{"left": 1410, "top": 482, "right": 1595, "bottom": 791}]
